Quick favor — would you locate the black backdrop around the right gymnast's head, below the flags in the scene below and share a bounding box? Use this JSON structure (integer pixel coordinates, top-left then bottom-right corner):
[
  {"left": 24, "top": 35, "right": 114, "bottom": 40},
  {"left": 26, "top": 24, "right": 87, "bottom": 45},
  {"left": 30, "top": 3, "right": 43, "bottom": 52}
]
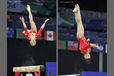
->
[{"left": 58, "top": 50, "right": 107, "bottom": 75}]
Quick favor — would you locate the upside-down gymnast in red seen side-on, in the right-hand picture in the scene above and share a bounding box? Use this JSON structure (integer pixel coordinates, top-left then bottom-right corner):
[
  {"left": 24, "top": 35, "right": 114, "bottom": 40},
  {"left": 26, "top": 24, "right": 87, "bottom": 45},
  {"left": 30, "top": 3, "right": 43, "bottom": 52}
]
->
[{"left": 73, "top": 4, "right": 101, "bottom": 64}]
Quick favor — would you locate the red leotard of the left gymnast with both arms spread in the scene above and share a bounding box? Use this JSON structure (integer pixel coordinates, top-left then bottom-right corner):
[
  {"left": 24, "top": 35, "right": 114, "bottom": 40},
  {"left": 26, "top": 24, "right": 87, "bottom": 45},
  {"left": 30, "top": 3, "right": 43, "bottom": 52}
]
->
[{"left": 25, "top": 28, "right": 43, "bottom": 39}]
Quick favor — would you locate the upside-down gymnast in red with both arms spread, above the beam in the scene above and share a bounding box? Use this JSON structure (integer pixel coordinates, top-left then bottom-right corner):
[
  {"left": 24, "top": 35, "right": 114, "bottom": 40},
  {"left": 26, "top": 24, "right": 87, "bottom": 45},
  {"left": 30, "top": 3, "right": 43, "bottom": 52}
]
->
[{"left": 20, "top": 5, "right": 49, "bottom": 46}]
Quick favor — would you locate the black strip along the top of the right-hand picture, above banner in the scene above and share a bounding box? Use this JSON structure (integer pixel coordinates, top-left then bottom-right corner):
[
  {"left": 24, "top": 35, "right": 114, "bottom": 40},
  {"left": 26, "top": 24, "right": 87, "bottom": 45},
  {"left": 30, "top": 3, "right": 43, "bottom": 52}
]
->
[{"left": 58, "top": 0, "right": 107, "bottom": 12}]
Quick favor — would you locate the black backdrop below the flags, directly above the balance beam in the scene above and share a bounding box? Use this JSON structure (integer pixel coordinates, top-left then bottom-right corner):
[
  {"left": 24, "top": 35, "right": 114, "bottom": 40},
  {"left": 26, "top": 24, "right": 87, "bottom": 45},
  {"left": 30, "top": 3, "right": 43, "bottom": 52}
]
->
[{"left": 7, "top": 39, "right": 56, "bottom": 76}]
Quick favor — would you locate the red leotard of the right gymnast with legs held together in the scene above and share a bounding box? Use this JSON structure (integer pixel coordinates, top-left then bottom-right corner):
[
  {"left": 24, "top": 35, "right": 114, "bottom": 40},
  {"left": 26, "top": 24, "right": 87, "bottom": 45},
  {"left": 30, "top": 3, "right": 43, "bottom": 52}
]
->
[{"left": 77, "top": 36, "right": 91, "bottom": 54}]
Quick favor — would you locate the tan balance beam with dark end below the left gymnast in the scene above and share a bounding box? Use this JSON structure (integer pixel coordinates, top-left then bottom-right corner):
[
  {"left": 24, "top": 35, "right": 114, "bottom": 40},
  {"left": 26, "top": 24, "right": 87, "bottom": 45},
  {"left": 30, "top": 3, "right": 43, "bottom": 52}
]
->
[{"left": 13, "top": 65, "right": 44, "bottom": 72}]
